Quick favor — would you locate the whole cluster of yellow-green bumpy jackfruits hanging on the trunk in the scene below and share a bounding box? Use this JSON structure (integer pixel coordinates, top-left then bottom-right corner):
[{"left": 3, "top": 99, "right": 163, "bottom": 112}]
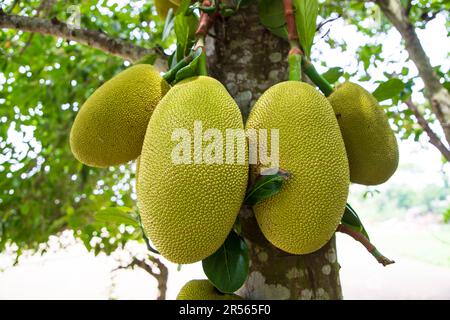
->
[{"left": 70, "top": 57, "right": 398, "bottom": 299}]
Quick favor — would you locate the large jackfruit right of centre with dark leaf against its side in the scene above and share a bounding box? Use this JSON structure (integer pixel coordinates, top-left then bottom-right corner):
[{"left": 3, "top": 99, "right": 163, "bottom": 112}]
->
[{"left": 246, "top": 81, "right": 350, "bottom": 254}]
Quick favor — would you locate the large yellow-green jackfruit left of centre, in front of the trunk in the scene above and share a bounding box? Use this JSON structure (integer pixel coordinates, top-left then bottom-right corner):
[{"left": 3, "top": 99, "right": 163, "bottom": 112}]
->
[{"left": 137, "top": 76, "right": 248, "bottom": 264}]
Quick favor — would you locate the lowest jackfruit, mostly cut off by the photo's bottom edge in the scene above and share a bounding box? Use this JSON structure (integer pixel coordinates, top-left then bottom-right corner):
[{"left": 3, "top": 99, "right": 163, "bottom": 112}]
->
[{"left": 177, "top": 280, "right": 242, "bottom": 300}]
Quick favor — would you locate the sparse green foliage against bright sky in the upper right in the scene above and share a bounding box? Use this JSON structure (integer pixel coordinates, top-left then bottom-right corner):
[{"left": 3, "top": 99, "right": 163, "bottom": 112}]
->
[{"left": 316, "top": 0, "right": 450, "bottom": 145}]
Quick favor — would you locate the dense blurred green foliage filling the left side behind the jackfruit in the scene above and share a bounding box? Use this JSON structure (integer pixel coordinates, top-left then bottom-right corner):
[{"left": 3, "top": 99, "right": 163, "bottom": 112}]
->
[{"left": 0, "top": 1, "right": 169, "bottom": 260}]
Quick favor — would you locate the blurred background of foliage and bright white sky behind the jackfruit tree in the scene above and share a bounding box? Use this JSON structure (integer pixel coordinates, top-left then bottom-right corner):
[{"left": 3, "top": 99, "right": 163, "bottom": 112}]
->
[{"left": 0, "top": 0, "right": 450, "bottom": 299}]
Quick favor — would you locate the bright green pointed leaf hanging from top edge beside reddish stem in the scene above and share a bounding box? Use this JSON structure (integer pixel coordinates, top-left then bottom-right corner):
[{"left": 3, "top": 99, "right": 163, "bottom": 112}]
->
[{"left": 294, "top": 0, "right": 319, "bottom": 57}]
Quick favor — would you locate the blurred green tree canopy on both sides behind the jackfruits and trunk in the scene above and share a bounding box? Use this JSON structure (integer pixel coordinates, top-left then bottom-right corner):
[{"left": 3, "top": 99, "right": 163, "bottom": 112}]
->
[{"left": 0, "top": 0, "right": 450, "bottom": 280}]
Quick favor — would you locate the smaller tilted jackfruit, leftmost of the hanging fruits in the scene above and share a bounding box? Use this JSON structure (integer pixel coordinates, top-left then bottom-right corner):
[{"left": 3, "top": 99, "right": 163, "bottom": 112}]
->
[{"left": 70, "top": 64, "right": 170, "bottom": 167}]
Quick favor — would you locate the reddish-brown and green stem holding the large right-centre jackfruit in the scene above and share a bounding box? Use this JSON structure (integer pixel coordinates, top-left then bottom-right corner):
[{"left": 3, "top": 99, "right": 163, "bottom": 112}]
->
[{"left": 283, "top": 0, "right": 303, "bottom": 81}]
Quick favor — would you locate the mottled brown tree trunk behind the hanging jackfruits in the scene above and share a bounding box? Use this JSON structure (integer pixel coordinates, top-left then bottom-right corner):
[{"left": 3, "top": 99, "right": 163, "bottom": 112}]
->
[{"left": 208, "top": 5, "right": 342, "bottom": 299}]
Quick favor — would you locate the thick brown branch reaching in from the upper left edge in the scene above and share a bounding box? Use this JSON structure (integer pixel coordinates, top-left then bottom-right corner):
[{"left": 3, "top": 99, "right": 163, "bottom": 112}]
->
[{"left": 0, "top": 9, "right": 165, "bottom": 68}]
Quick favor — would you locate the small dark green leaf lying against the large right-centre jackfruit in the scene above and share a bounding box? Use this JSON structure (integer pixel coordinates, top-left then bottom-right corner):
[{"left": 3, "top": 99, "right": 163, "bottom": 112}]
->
[{"left": 244, "top": 171, "right": 289, "bottom": 206}]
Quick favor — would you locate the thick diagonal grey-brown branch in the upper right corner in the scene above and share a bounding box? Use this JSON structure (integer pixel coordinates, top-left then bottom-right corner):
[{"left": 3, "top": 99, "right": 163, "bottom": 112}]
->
[{"left": 375, "top": 0, "right": 450, "bottom": 144}]
